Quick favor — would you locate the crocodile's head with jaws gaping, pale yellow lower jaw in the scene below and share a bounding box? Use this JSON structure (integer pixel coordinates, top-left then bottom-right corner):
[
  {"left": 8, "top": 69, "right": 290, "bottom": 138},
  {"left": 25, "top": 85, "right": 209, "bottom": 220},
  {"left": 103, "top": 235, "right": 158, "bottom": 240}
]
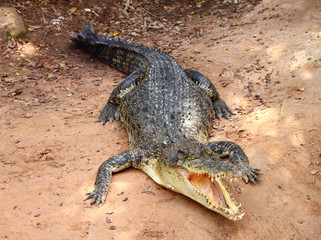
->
[{"left": 157, "top": 159, "right": 244, "bottom": 220}]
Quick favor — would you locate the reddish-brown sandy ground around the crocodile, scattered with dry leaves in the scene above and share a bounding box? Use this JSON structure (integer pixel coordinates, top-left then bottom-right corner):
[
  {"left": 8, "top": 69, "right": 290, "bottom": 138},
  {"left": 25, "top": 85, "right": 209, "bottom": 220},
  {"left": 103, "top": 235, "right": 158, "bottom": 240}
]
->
[{"left": 0, "top": 0, "right": 321, "bottom": 240}]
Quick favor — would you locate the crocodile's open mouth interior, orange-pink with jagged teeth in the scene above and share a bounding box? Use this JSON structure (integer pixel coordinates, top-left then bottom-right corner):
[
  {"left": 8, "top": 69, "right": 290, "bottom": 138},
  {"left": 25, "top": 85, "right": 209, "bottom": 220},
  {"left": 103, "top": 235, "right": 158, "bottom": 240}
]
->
[{"left": 186, "top": 171, "right": 244, "bottom": 220}]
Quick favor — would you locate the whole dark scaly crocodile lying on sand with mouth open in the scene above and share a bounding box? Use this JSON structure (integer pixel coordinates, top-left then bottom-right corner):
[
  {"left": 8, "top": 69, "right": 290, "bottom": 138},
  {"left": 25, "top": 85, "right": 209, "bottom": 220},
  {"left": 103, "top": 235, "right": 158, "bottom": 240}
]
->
[{"left": 71, "top": 22, "right": 261, "bottom": 220}]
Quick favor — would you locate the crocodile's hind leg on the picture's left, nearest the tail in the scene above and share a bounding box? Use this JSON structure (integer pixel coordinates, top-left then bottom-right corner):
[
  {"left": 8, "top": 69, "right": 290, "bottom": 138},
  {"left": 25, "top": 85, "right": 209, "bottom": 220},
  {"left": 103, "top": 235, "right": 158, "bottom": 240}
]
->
[{"left": 96, "top": 70, "right": 145, "bottom": 125}]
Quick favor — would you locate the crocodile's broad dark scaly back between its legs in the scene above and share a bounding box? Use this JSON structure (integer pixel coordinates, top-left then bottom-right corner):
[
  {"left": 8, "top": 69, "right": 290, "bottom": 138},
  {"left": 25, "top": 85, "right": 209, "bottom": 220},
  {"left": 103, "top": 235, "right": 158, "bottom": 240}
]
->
[{"left": 120, "top": 50, "right": 213, "bottom": 148}]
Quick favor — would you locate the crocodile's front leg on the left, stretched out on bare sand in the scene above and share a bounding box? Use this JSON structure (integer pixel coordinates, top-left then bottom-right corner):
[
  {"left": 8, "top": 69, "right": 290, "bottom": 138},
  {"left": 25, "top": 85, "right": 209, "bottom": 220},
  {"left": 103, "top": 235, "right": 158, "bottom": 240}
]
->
[{"left": 85, "top": 151, "right": 135, "bottom": 206}]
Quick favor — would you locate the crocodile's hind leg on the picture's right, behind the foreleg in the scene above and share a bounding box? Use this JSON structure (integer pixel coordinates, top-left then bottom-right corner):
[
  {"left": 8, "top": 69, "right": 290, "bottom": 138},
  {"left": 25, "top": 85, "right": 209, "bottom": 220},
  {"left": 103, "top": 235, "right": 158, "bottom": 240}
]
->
[{"left": 184, "top": 69, "right": 234, "bottom": 120}]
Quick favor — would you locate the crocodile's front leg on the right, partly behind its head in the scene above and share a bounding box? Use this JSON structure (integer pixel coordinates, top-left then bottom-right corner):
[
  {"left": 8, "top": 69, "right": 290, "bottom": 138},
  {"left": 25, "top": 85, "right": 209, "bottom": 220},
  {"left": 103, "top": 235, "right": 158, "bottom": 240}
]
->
[{"left": 207, "top": 141, "right": 262, "bottom": 183}]
